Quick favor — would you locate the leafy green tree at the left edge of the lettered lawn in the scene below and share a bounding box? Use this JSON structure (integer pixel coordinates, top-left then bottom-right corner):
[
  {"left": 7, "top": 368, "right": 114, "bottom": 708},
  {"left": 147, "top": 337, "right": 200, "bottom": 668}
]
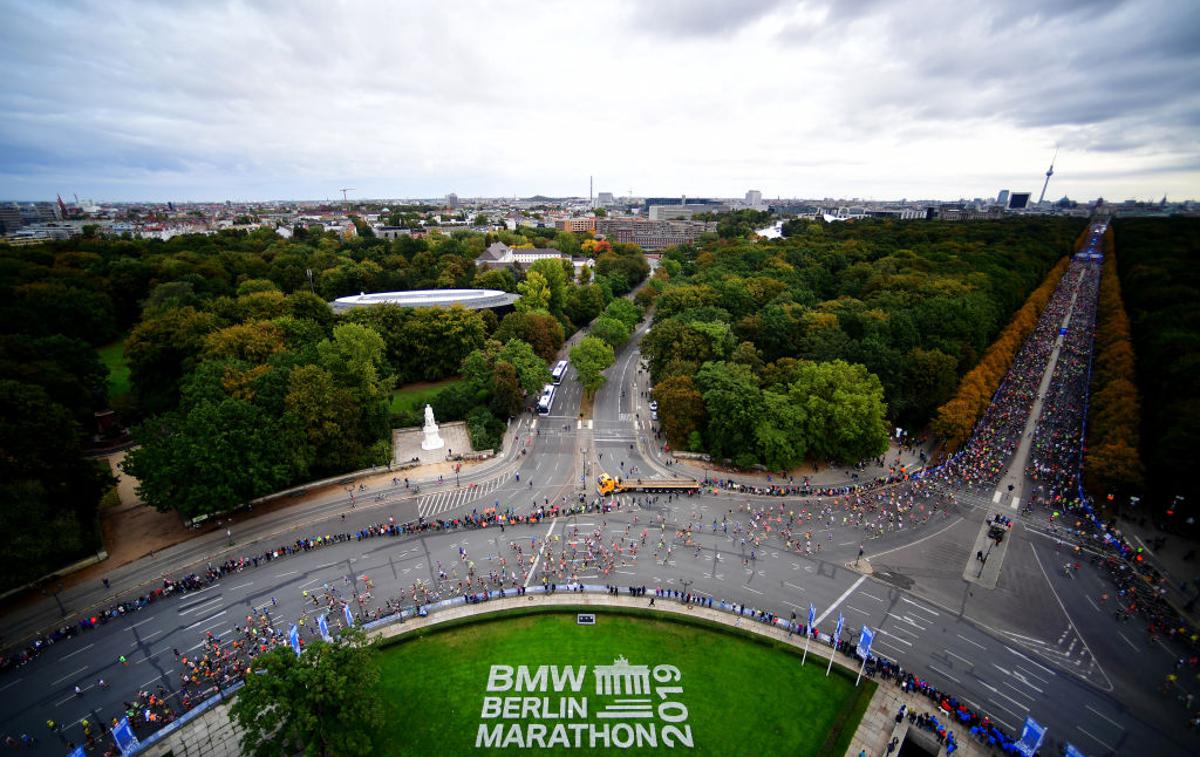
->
[{"left": 229, "top": 629, "right": 384, "bottom": 757}]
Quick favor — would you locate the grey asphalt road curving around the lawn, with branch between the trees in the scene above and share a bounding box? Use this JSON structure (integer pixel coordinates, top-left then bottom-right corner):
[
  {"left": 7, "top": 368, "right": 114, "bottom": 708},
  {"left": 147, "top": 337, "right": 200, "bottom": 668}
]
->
[{"left": 0, "top": 226, "right": 1200, "bottom": 755}]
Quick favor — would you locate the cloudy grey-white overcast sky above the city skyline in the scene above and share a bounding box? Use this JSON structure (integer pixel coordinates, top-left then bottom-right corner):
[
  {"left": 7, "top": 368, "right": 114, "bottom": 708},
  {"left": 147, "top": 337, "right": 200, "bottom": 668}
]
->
[{"left": 0, "top": 0, "right": 1200, "bottom": 200}]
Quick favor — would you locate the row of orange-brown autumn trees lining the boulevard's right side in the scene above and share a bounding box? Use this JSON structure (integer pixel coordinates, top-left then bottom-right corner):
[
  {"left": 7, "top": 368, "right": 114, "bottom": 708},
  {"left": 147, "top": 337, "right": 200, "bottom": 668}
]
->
[{"left": 1084, "top": 228, "right": 1145, "bottom": 501}]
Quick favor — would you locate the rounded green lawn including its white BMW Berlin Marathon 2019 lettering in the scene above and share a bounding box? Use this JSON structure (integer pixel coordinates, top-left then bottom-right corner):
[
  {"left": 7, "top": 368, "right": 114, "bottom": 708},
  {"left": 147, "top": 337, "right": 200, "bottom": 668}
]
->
[{"left": 379, "top": 607, "right": 875, "bottom": 755}]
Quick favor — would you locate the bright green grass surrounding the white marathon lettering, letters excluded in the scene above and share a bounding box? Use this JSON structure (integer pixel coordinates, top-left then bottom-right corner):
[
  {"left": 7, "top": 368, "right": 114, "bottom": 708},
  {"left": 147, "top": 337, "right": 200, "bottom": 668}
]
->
[{"left": 379, "top": 608, "right": 875, "bottom": 756}]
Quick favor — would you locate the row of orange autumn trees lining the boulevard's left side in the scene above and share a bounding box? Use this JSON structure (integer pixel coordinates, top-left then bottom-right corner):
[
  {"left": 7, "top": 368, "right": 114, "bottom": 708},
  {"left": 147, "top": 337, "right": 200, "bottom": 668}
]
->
[{"left": 931, "top": 258, "right": 1070, "bottom": 451}]
